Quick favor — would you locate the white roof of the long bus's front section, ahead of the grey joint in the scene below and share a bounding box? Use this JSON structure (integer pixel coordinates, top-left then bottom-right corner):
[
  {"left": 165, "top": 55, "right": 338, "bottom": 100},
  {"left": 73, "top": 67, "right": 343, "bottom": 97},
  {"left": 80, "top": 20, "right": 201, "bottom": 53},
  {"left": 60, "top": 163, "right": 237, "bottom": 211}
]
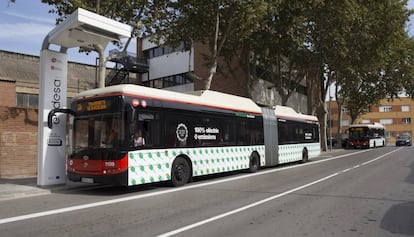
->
[{"left": 74, "top": 84, "right": 262, "bottom": 114}]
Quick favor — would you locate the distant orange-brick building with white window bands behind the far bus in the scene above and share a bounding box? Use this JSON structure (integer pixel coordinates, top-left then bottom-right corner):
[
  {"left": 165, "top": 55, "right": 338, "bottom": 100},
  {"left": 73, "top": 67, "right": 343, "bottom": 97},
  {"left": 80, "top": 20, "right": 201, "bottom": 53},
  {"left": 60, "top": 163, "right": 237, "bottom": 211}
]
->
[{"left": 327, "top": 97, "right": 414, "bottom": 144}]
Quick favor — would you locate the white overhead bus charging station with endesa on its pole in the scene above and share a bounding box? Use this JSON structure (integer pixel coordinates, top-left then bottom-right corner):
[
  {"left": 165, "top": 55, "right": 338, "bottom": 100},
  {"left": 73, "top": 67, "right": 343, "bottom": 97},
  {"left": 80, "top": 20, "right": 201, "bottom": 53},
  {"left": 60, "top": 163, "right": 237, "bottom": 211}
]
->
[{"left": 37, "top": 8, "right": 131, "bottom": 185}]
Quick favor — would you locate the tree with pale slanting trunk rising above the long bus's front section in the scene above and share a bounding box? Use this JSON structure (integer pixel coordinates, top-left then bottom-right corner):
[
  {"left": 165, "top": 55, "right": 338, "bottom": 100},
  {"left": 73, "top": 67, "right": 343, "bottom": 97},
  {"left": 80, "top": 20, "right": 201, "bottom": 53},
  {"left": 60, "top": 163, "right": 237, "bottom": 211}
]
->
[{"left": 152, "top": 0, "right": 267, "bottom": 90}]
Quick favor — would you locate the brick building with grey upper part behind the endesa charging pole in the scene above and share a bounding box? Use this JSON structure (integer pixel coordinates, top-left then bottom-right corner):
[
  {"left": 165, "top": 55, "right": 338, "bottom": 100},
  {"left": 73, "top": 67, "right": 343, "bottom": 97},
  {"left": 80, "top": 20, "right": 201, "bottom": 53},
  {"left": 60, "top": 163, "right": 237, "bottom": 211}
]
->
[{"left": 0, "top": 50, "right": 95, "bottom": 178}]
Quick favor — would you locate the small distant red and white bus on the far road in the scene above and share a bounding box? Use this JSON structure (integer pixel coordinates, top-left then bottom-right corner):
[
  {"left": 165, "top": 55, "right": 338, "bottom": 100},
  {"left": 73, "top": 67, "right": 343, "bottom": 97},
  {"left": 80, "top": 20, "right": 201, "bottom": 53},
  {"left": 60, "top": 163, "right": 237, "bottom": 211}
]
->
[{"left": 348, "top": 123, "right": 386, "bottom": 148}]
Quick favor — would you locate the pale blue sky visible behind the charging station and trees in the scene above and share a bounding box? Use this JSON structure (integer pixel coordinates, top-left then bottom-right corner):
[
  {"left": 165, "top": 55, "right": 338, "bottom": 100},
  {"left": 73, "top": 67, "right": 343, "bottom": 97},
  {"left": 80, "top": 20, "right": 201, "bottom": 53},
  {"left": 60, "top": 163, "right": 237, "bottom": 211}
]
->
[{"left": 0, "top": 0, "right": 414, "bottom": 65}]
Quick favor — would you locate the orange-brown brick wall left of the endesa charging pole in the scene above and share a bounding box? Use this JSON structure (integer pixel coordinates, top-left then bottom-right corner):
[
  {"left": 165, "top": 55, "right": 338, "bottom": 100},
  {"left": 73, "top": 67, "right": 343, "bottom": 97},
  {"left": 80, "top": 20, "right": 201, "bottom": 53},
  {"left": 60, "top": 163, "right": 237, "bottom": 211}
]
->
[{"left": 0, "top": 106, "right": 38, "bottom": 178}]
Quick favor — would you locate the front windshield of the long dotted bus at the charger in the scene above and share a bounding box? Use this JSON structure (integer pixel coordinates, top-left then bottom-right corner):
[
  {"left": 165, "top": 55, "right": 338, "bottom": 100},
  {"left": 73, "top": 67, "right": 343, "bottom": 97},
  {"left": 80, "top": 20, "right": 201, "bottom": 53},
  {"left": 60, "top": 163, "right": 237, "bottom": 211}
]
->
[{"left": 73, "top": 113, "right": 123, "bottom": 151}]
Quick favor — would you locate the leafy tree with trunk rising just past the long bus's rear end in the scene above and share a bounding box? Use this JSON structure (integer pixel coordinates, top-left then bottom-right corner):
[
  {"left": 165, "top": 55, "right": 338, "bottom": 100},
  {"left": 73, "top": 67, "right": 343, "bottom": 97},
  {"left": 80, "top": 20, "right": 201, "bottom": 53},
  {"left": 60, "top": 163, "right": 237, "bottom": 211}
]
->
[{"left": 302, "top": 0, "right": 409, "bottom": 150}]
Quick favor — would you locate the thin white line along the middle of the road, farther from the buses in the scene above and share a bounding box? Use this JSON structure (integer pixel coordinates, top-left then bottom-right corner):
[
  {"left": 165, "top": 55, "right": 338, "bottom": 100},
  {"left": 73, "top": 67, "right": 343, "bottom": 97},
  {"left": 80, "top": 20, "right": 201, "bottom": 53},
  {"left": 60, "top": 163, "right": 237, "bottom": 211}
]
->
[{"left": 158, "top": 149, "right": 400, "bottom": 237}]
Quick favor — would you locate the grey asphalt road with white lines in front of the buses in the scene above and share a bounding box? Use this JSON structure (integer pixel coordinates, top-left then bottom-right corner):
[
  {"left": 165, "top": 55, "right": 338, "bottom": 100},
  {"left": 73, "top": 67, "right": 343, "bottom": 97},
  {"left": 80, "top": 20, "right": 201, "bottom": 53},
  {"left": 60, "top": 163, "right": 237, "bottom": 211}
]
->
[{"left": 0, "top": 147, "right": 414, "bottom": 237}]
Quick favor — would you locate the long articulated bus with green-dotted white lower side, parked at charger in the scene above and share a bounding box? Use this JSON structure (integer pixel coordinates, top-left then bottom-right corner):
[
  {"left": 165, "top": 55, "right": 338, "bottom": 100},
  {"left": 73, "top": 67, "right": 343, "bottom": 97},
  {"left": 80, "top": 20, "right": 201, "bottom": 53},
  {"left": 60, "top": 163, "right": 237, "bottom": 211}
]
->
[{"left": 49, "top": 85, "right": 320, "bottom": 186}]
